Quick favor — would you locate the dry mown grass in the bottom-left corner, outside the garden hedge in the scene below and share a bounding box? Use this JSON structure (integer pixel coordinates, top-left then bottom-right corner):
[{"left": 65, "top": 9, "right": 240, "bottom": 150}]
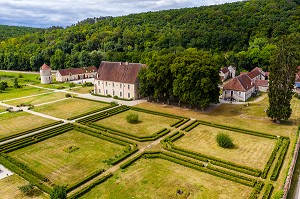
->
[{"left": 0, "top": 174, "right": 49, "bottom": 199}]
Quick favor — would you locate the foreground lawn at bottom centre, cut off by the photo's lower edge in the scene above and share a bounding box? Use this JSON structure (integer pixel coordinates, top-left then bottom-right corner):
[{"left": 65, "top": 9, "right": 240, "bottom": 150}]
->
[{"left": 82, "top": 159, "right": 252, "bottom": 199}]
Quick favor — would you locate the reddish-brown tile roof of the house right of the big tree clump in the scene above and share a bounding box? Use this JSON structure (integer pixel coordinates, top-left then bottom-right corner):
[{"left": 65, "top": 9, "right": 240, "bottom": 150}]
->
[{"left": 223, "top": 74, "right": 255, "bottom": 92}]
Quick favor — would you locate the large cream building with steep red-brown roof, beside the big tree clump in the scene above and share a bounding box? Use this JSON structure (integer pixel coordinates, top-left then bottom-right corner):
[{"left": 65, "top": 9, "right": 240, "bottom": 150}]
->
[{"left": 94, "top": 61, "right": 144, "bottom": 99}]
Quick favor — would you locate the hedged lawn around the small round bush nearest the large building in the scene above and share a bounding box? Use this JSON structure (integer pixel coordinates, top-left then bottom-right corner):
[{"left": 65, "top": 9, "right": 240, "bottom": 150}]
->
[{"left": 96, "top": 110, "right": 178, "bottom": 136}]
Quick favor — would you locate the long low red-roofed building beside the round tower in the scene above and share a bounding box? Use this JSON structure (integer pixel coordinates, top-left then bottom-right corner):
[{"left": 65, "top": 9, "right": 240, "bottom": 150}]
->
[{"left": 55, "top": 66, "right": 97, "bottom": 82}]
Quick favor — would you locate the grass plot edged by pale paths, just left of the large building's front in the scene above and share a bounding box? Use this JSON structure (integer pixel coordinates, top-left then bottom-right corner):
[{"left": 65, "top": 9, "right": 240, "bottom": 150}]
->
[{"left": 33, "top": 98, "right": 108, "bottom": 119}]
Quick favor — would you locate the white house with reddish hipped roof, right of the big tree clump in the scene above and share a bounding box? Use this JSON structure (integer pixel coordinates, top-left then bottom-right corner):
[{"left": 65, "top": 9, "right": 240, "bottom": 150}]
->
[{"left": 222, "top": 74, "right": 255, "bottom": 101}]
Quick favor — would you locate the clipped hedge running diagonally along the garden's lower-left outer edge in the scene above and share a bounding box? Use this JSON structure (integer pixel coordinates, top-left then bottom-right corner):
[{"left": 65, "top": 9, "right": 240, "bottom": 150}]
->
[{"left": 0, "top": 156, "right": 51, "bottom": 194}]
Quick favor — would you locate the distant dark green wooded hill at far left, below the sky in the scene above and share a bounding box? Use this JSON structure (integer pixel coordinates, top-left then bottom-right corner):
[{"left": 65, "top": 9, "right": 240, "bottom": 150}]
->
[{"left": 0, "top": 25, "right": 41, "bottom": 42}]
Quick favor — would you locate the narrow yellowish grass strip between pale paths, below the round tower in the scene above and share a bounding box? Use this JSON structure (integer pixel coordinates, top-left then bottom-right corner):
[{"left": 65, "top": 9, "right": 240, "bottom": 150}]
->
[{"left": 6, "top": 92, "right": 66, "bottom": 106}]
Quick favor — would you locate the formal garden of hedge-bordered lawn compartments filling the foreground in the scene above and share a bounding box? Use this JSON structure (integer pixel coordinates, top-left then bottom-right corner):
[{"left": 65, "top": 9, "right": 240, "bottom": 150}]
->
[{"left": 0, "top": 104, "right": 296, "bottom": 198}]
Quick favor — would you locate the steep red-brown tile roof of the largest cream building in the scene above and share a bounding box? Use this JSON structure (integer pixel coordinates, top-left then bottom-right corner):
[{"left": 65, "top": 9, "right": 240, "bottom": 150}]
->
[{"left": 97, "top": 61, "right": 143, "bottom": 84}]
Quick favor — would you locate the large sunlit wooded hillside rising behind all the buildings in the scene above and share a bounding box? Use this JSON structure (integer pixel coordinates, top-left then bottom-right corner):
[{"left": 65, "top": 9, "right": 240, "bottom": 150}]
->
[{"left": 0, "top": 0, "right": 300, "bottom": 71}]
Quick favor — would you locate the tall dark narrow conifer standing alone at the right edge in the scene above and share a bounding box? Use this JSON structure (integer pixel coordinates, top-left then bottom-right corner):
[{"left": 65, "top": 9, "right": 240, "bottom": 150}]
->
[{"left": 267, "top": 35, "right": 300, "bottom": 122}]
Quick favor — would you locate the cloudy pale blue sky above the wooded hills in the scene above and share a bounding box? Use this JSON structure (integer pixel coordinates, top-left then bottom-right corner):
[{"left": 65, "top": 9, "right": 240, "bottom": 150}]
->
[{"left": 0, "top": 0, "right": 241, "bottom": 28}]
